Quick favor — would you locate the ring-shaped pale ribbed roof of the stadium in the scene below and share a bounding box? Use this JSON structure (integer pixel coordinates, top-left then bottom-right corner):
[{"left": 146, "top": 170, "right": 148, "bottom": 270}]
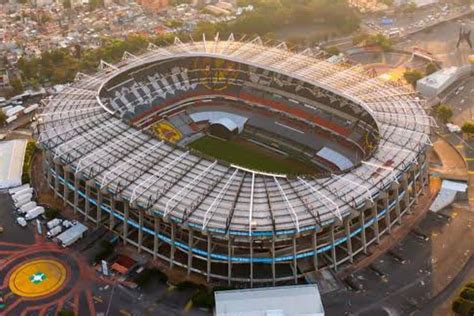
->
[{"left": 38, "top": 36, "right": 432, "bottom": 235}]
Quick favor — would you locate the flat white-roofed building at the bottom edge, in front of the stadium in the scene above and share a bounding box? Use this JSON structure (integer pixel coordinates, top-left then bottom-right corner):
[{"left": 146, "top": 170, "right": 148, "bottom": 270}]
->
[{"left": 215, "top": 284, "right": 324, "bottom": 316}]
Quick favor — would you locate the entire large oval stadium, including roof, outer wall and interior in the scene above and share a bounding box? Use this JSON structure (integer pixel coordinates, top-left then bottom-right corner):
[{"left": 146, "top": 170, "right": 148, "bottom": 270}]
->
[{"left": 36, "top": 35, "right": 432, "bottom": 286}]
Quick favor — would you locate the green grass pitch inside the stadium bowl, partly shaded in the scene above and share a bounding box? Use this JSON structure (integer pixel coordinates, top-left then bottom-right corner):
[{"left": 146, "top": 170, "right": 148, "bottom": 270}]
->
[{"left": 188, "top": 136, "right": 318, "bottom": 175}]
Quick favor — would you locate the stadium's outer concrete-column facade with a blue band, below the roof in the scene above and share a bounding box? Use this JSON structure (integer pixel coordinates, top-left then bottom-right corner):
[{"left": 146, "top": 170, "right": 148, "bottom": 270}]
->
[{"left": 44, "top": 150, "right": 429, "bottom": 286}]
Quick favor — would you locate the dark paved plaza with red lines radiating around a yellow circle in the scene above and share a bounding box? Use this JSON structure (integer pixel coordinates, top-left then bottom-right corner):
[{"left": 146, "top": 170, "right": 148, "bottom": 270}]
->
[{"left": 0, "top": 192, "right": 209, "bottom": 316}]
